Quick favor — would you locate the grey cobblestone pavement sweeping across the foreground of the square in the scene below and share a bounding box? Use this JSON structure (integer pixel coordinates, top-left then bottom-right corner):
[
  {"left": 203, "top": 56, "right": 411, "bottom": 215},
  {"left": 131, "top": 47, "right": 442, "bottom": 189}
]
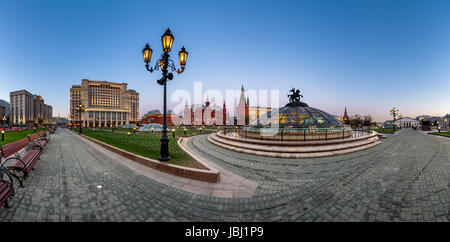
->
[{"left": 0, "top": 129, "right": 450, "bottom": 221}]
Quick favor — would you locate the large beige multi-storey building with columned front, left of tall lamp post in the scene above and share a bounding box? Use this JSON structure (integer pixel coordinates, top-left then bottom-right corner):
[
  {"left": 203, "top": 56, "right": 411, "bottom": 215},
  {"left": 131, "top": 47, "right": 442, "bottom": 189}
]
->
[{"left": 70, "top": 79, "right": 139, "bottom": 127}]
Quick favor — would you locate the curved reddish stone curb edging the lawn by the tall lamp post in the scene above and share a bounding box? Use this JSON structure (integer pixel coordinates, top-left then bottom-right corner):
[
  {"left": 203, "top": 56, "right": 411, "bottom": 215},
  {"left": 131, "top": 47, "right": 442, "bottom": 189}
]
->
[{"left": 75, "top": 131, "right": 220, "bottom": 183}]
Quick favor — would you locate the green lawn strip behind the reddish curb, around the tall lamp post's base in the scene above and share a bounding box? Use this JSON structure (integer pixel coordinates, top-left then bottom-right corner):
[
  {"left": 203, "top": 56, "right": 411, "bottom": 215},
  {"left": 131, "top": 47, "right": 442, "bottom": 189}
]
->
[{"left": 73, "top": 128, "right": 203, "bottom": 168}]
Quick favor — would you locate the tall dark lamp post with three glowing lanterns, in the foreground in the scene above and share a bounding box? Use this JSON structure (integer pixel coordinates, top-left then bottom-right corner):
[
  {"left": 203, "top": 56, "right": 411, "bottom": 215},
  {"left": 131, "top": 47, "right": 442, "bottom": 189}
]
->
[{"left": 142, "top": 29, "right": 188, "bottom": 161}]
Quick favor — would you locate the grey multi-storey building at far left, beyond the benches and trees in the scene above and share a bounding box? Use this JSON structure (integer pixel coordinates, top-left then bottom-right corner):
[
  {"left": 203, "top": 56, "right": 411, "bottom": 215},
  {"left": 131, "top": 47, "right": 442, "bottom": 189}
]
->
[{"left": 9, "top": 90, "right": 53, "bottom": 125}]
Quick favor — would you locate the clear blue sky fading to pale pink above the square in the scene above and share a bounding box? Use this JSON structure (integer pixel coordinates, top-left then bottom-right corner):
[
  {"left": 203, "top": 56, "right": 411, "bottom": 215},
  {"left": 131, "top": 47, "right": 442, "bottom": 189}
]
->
[{"left": 0, "top": 0, "right": 450, "bottom": 121}]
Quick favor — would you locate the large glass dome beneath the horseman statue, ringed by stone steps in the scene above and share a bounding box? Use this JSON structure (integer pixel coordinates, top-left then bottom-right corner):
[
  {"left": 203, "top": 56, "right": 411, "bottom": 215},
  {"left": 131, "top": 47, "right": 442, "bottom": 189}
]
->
[{"left": 252, "top": 105, "right": 344, "bottom": 128}]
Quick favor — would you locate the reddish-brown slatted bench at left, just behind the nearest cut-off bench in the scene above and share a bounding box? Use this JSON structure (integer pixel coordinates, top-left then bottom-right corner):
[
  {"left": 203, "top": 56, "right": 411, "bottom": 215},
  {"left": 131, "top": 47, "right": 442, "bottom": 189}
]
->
[{"left": 0, "top": 138, "right": 42, "bottom": 187}]
